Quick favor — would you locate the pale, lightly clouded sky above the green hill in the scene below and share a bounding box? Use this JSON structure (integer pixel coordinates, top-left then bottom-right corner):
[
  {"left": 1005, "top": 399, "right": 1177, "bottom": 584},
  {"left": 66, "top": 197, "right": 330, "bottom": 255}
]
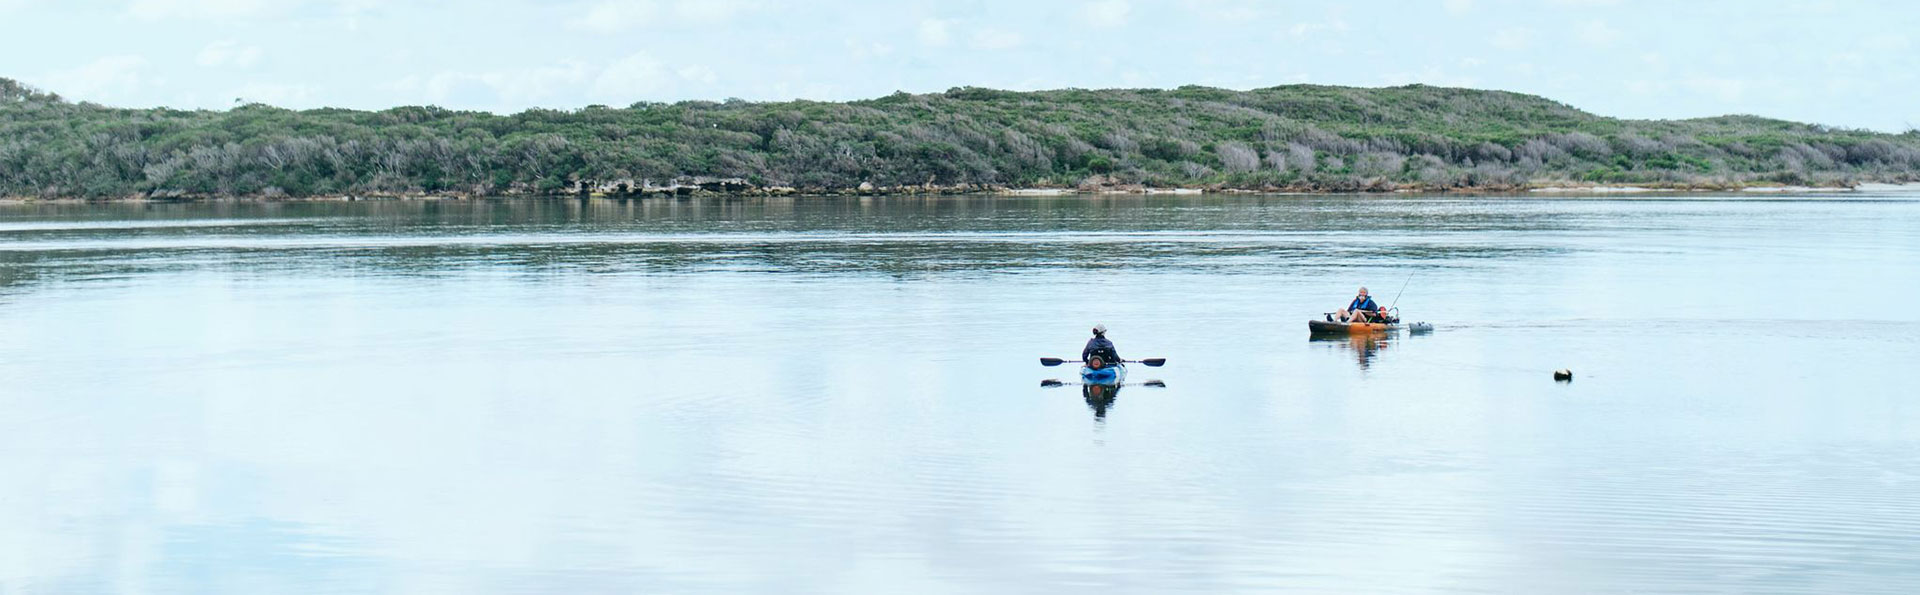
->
[{"left": 0, "top": 0, "right": 1920, "bottom": 132}]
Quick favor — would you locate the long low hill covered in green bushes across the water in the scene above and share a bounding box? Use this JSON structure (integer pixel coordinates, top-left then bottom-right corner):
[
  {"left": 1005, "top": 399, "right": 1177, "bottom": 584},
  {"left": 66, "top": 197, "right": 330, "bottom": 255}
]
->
[{"left": 0, "top": 79, "right": 1920, "bottom": 198}]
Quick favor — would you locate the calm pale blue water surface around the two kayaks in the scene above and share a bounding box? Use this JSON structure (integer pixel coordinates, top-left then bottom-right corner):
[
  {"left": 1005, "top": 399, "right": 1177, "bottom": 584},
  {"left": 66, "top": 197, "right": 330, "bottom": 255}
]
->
[{"left": 0, "top": 194, "right": 1920, "bottom": 593}]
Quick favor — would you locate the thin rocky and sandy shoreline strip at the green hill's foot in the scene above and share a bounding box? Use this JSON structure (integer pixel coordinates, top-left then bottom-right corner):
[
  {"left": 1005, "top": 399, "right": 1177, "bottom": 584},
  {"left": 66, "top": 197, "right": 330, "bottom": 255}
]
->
[{"left": 0, "top": 182, "right": 1920, "bottom": 203}]
